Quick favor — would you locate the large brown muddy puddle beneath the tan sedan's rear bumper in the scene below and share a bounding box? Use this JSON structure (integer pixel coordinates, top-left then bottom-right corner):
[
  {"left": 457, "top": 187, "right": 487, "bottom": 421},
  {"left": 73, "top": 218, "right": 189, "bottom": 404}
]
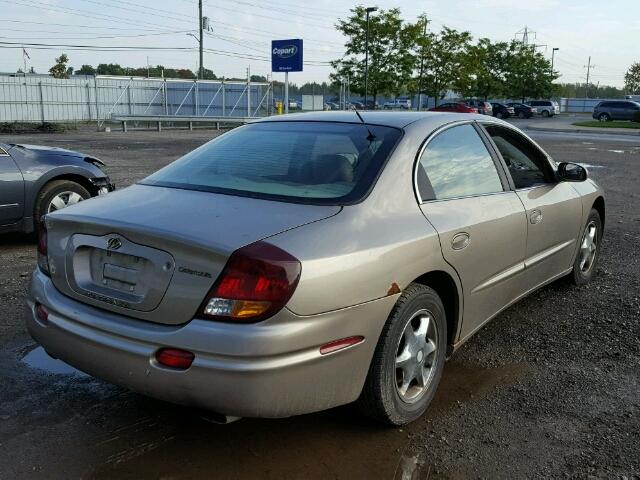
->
[{"left": 90, "top": 360, "right": 526, "bottom": 479}]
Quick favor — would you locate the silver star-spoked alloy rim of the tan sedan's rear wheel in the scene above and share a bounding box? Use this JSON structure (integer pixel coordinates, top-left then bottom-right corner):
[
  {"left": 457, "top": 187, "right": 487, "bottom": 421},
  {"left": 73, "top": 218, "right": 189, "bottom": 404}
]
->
[{"left": 395, "top": 310, "right": 438, "bottom": 403}]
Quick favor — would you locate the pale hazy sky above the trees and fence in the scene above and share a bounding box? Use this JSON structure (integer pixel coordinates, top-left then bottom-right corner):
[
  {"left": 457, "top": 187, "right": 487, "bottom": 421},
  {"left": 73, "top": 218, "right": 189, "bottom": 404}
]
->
[{"left": 0, "top": 0, "right": 640, "bottom": 87}]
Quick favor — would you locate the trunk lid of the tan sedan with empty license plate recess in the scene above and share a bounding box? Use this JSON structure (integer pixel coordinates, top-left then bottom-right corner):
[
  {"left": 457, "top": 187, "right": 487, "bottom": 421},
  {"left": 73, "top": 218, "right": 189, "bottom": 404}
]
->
[{"left": 47, "top": 185, "right": 340, "bottom": 324}]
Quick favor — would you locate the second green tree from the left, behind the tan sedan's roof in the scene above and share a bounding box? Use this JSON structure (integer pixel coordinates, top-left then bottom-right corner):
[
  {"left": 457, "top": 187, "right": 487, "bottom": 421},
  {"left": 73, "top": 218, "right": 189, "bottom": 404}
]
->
[{"left": 423, "top": 26, "right": 472, "bottom": 105}]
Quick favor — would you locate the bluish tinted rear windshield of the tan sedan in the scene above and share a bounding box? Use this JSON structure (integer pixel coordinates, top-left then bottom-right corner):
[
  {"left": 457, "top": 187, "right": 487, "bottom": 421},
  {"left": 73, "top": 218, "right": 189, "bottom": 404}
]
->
[{"left": 140, "top": 122, "right": 401, "bottom": 204}]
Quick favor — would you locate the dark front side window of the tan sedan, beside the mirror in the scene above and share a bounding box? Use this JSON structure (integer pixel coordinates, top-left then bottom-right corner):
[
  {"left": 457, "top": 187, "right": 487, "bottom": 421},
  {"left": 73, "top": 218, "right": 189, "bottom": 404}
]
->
[{"left": 485, "top": 125, "right": 553, "bottom": 188}]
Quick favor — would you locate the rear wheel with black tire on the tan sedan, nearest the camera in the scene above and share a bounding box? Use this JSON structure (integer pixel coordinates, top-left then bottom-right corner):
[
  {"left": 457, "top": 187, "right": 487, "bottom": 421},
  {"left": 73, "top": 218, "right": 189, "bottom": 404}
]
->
[{"left": 358, "top": 283, "right": 447, "bottom": 425}]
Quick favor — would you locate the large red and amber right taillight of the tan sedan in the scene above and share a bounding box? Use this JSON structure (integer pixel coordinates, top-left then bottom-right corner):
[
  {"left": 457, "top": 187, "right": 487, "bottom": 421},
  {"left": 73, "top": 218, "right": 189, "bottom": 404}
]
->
[{"left": 199, "top": 242, "right": 302, "bottom": 322}]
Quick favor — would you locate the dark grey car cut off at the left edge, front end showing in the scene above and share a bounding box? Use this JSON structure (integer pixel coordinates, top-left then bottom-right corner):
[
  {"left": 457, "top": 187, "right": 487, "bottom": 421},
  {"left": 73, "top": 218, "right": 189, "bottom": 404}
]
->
[{"left": 0, "top": 143, "right": 115, "bottom": 233}]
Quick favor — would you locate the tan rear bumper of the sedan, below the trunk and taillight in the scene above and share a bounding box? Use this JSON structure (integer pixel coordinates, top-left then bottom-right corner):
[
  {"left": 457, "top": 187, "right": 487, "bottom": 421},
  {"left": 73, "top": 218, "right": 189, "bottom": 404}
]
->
[{"left": 26, "top": 271, "right": 396, "bottom": 418}]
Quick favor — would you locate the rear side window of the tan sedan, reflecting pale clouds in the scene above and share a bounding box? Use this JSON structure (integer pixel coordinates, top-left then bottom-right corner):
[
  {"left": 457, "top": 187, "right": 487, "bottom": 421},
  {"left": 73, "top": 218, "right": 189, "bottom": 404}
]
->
[{"left": 417, "top": 124, "right": 503, "bottom": 201}]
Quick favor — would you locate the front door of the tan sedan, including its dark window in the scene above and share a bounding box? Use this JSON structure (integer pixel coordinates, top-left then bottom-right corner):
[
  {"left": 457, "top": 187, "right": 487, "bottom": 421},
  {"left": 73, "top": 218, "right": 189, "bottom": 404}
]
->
[{"left": 484, "top": 124, "right": 582, "bottom": 290}]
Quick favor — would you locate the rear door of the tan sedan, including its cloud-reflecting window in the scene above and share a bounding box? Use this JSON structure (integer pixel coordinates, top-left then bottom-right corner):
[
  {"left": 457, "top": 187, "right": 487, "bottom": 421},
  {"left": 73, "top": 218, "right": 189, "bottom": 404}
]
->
[{"left": 416, "top": 122, "right": 527, "bottom": 337}]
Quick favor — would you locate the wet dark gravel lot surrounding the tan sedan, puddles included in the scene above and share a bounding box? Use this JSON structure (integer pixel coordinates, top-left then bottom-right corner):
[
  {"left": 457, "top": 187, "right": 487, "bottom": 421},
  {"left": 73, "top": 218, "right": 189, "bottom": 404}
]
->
[{"left": 0, "top": 125, "right": 640, "bottom": 479}]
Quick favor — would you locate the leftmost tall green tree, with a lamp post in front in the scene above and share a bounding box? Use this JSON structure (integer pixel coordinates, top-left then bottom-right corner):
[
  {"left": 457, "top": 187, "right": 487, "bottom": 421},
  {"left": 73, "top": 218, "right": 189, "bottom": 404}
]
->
[{"left": 330, "top": 6, "right": 419, "bottom": 101}]
